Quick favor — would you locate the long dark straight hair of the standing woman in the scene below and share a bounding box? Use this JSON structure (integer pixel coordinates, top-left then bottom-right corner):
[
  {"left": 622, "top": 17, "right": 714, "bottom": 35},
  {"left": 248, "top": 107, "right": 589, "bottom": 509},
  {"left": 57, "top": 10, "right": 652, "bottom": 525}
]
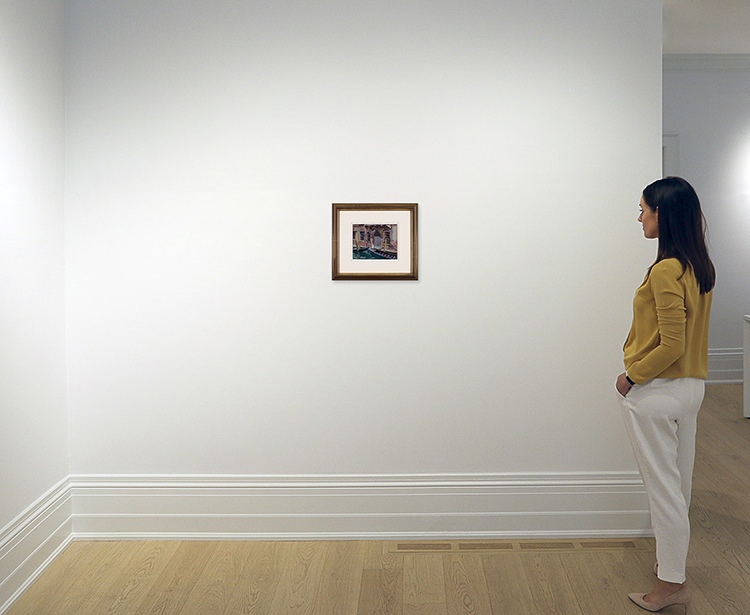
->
[{"left": 643, "top": 177, "right": 716, "bottom": 294}]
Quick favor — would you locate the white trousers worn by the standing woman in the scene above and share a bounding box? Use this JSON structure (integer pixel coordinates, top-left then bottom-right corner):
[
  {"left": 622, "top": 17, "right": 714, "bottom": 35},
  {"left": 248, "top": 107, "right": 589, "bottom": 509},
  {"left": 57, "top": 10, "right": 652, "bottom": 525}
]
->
[{"left": 623, "top": 378, "right": 705, "bottom": 583}]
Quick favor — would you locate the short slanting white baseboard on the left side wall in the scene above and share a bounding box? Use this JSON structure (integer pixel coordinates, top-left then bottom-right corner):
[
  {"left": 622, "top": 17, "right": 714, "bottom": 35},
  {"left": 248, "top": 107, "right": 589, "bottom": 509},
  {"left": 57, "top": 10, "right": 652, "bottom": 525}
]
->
[{"left": 0, "top": 478, "right": 73, "bottom": 613}]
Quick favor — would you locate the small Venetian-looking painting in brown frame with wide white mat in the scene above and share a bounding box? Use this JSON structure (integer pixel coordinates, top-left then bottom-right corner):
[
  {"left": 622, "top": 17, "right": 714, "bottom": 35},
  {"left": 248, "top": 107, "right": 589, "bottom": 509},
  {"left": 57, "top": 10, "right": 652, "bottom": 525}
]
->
[{"left": 332, "top": 203, "right": 417, "bottom": 280}]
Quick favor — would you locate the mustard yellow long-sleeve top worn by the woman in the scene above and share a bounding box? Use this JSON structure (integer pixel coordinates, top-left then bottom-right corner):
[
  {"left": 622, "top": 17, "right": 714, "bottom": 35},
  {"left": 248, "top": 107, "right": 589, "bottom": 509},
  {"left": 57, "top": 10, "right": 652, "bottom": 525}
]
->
[{"left": 623, "top": 258, "right": 713, "bottom": 384}]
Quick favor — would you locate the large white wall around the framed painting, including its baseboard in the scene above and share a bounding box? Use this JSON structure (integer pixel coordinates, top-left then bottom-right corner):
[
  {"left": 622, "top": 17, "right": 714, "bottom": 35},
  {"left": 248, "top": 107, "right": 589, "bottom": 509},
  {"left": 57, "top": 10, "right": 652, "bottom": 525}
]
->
[{"left": 66, "top": 0, "right": 661, "bottom": 534}]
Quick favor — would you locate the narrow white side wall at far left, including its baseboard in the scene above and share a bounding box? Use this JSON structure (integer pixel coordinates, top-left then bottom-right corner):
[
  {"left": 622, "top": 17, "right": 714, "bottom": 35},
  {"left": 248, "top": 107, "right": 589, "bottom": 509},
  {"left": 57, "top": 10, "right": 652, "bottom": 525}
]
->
[{"left": 0, "top": 0, "right": 71, "bottom": 610}]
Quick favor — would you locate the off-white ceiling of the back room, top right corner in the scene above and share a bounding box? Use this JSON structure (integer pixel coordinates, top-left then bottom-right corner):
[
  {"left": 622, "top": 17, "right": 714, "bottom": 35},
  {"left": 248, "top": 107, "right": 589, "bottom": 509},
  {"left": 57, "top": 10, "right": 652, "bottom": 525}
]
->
[{"left": 663, "top": 0, "right": 750, "bottom": 54}]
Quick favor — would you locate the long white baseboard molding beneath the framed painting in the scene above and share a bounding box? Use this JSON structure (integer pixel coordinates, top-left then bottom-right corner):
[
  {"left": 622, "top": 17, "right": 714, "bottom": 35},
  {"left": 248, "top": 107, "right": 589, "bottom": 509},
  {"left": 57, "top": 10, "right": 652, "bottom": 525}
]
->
[{"left": 71, "top": 473, "right": 651, "bottom": 540}]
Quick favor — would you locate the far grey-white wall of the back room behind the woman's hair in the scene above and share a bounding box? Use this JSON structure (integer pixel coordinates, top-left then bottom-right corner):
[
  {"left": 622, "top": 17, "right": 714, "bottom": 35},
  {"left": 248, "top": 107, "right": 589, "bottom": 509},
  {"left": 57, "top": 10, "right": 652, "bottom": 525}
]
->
[{"left": 664, "top": 55, "right": 750, "bottom": 381}]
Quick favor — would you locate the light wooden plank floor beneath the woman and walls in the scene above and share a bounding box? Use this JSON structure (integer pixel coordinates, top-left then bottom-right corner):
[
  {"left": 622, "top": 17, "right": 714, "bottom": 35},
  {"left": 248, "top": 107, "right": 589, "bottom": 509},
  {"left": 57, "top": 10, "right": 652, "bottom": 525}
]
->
[{"left": 9, "top": 385, "right": 750, "bottom": 615}]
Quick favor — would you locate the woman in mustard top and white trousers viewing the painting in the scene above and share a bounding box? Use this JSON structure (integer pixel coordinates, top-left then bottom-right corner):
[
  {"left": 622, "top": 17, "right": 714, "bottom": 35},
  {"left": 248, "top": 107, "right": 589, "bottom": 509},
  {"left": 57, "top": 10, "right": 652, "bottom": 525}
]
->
[{"left": 616, "top": 177, "right": 716, "bottom": 614}]
